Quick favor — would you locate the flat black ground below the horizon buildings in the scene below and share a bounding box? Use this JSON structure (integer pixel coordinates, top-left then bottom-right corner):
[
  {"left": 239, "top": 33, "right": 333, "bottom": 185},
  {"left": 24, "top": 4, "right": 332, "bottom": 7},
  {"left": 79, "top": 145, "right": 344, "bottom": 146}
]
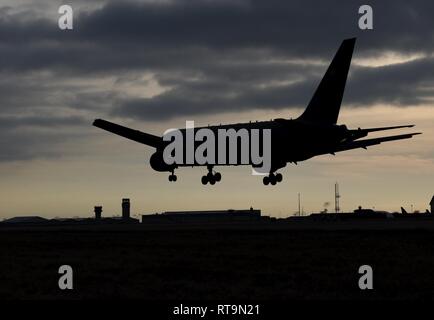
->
[{"left": 0, "top": 221, "right": 434, "bottom": 301}]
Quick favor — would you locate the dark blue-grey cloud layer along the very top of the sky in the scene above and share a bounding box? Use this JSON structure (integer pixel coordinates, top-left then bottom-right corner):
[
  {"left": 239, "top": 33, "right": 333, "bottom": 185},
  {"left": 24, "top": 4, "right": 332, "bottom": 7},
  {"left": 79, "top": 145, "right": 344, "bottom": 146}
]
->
[{"left": 0, "top": 0, "right": 434, "bottom": 71}]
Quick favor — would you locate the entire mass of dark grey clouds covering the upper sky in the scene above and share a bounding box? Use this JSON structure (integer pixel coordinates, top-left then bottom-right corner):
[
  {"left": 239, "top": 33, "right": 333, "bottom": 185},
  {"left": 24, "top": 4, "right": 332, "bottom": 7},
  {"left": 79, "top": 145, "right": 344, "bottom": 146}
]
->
[{"left": 0, "top": 0, "right": 434, "bottom": 159}]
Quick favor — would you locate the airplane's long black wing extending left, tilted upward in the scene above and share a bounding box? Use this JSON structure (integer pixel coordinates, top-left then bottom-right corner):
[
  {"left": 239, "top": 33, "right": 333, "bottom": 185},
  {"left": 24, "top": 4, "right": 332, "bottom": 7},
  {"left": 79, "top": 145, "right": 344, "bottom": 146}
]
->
[{"left": 93, "top": 119, "right": 163, "bottom": 148}]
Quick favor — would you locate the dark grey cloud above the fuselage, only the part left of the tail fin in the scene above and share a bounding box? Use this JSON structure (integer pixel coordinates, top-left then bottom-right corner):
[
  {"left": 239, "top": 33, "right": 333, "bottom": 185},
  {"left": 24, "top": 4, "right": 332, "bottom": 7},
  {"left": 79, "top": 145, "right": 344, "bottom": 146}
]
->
[{"left": 113, "top": 73, "right": 312, "bottom": 120}]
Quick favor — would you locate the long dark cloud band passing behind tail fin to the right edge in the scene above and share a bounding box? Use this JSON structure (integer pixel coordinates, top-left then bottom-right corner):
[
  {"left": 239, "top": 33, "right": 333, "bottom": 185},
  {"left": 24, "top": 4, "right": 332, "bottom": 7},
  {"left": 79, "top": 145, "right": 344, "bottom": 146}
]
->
[{"left": 113, "top": 58, "right": 434, "bottom": 120}]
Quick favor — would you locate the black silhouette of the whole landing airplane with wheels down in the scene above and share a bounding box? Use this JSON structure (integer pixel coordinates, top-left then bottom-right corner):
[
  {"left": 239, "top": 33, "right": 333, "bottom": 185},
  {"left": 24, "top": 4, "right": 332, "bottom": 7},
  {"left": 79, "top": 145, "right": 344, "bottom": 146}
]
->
[{"left": 93, "top": 38, "right": 421, "bottom": 185}]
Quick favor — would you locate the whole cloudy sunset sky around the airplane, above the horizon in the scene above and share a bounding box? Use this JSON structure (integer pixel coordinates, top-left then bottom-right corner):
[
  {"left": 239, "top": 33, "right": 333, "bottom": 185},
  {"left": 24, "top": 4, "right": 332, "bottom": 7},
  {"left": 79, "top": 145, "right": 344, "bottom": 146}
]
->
[{"left": 0, "top": 0, "right": 434, "bottom": 219}]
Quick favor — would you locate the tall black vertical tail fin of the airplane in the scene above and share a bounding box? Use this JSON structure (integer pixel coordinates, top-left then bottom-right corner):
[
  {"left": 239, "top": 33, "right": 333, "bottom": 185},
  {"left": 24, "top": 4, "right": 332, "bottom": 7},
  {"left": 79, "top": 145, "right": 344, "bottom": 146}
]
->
[{"left": 299, "top": 38, "right": 356, "bottom": 124}]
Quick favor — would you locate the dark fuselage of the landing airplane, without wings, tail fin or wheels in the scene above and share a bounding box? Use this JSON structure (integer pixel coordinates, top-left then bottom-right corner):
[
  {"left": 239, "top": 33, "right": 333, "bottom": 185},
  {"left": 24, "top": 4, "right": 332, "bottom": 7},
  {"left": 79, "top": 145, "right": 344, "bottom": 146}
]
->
[{"left": 151, "top": 119, "right": 348, "bottom": 171}]
